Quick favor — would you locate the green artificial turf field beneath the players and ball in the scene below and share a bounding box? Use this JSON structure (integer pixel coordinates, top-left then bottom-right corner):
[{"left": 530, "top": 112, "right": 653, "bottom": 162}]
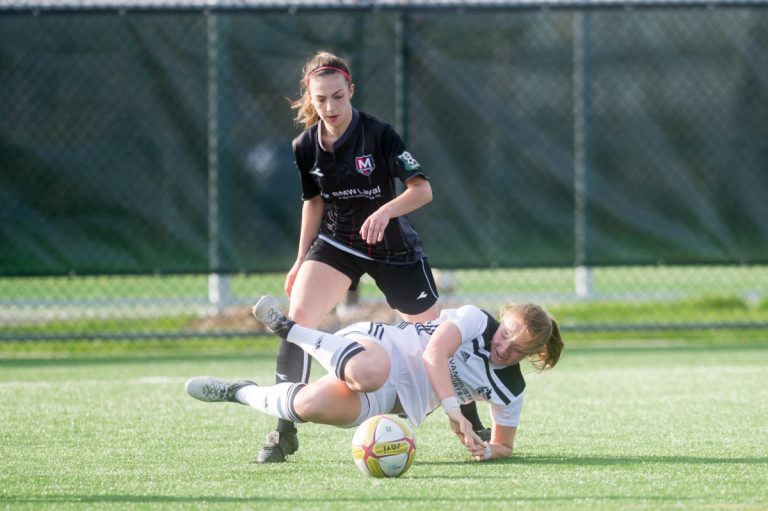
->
[{"left": 0, "top": 337, "right": 768, "bottom": 510}]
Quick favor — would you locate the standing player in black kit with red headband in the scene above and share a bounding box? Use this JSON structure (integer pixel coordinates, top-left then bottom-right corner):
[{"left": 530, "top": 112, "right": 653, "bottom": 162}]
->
[{"left": 257, "top": 52, "right": 483, "bottom": 463}]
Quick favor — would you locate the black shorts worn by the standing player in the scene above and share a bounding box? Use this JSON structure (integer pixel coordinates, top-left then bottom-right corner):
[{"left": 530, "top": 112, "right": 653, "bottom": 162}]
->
[{"left": 304, "top": 238, "right": 438, "bottom": 314}]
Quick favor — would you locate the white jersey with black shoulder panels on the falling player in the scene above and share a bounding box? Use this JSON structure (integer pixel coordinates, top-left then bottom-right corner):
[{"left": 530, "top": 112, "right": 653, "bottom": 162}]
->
[{"left": 336, "top": 305, "right": 525, "bottom": 427}]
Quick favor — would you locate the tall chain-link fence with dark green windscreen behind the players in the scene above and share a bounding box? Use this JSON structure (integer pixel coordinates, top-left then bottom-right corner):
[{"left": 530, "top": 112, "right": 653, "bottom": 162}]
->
[{"left": 0, "top": 2, "right": 768, "bottom": 339}]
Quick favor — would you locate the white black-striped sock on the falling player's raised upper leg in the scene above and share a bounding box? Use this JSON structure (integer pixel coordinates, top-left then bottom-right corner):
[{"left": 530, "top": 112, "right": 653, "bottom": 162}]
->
[{"left": 287, "top": 325, "right": 365, "bottom": 380}]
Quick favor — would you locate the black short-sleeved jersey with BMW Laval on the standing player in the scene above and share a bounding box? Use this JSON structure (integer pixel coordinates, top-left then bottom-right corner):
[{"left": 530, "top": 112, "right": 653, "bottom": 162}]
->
[{"left": 293, "top": 110, "right": 428, "bottom": 264}]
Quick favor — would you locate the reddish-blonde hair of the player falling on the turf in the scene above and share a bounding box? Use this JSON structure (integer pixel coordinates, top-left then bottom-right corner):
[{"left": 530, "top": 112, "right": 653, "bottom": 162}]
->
[{"left": 500, "top": 303, "right": 565, "bottom": 371}]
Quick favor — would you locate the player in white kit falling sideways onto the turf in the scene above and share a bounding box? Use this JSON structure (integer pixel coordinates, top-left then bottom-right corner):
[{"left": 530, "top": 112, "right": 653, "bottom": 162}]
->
[{"left": 186, "top": 296, "right": 563, "bottom": 460}]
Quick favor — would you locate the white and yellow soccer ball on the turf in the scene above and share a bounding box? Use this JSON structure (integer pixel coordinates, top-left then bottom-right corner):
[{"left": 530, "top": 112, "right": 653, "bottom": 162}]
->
[{"left": 352, "top": 415, "right": 416, "bottom": 477}]
